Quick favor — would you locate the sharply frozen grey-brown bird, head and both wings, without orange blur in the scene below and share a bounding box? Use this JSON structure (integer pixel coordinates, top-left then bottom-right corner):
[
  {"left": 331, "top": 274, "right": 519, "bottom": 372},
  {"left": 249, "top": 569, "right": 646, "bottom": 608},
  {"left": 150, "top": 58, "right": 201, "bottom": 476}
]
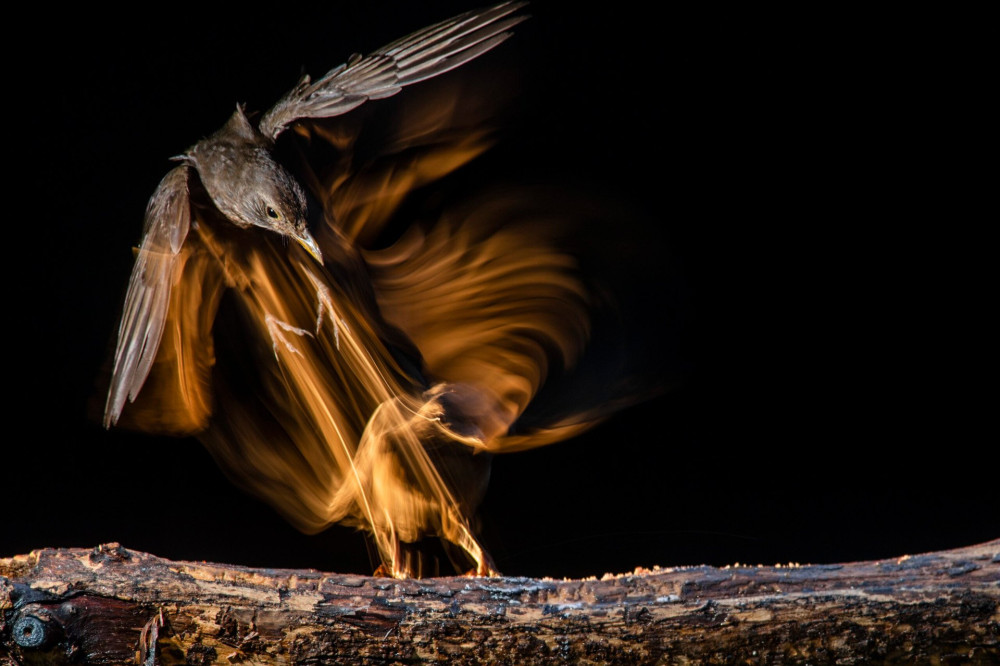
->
[{"left": 104, "top": 2, "right": 525, "bottom": 427}]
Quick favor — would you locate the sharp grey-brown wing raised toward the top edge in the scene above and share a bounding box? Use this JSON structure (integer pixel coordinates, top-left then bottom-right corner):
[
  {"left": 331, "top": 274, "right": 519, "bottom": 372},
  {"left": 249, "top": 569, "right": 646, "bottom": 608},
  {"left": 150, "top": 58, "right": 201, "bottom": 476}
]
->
[{"left": 260, "top": 2, "right": 527, "bottom": 139}]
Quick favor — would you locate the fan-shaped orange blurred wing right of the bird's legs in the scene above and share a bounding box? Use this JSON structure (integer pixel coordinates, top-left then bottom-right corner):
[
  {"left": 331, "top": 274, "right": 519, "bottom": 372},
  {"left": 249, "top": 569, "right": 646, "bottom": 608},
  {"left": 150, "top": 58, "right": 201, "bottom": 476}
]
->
[{"left": 365, "top": 193, "right": 590, "bottom": 451}]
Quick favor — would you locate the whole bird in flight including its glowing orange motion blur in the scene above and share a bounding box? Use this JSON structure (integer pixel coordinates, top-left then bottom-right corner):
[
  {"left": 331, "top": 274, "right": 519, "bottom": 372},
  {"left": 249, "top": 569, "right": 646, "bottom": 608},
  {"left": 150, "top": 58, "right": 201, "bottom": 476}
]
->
[{"left": 103, "top": 2, "right": 612, "bottom": 578}]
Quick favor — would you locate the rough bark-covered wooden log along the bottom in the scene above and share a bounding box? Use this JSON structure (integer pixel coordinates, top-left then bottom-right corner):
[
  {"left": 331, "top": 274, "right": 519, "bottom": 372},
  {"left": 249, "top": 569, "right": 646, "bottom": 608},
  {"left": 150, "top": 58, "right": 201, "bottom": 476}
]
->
[{"left": 0, "top": 539, "right": 1000, "bottom": 665}]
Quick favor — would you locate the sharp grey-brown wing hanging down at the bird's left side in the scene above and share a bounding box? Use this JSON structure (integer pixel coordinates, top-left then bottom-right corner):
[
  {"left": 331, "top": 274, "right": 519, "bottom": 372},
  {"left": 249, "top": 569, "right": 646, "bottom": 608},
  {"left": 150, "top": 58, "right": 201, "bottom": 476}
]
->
[{"left": 104, "top": 166, "right": 191, "bottom": 428}]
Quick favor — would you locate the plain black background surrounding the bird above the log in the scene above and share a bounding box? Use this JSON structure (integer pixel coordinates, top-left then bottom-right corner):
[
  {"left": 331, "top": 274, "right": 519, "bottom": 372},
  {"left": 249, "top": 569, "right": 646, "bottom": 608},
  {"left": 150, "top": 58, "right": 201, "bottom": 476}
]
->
[{"left": 0, "top": 2, "right": 1000, "bottom": 576}]
